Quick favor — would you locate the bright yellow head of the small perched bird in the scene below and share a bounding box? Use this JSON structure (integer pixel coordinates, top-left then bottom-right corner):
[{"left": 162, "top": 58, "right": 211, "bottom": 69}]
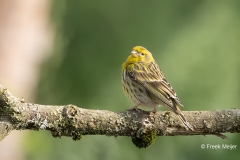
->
[{"left": 122, "top": 46, "right": 154, "bottom": 69}]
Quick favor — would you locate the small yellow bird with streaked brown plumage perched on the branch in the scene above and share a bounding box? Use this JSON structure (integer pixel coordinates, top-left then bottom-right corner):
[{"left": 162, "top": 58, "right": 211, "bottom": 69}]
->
[{"left": 122, "top": 46, "right": 193, "bottom": 131}]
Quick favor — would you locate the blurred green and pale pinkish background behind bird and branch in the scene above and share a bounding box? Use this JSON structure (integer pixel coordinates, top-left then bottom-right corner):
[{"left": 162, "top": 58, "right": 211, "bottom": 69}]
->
[{"left": 0, "top": 0, "right": 240, "bottom": 160}]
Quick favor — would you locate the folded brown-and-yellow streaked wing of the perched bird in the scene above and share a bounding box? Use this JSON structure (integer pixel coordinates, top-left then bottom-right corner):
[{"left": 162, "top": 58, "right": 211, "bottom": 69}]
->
[{"left": 129, "top": 62, "right": 183, "bottom": 108}]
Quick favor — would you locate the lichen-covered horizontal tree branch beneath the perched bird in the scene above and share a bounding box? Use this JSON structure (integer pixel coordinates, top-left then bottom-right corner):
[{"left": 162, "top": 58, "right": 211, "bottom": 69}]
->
[{"left": 0, "top": 85, "right": 240, "bottom": 148}]
